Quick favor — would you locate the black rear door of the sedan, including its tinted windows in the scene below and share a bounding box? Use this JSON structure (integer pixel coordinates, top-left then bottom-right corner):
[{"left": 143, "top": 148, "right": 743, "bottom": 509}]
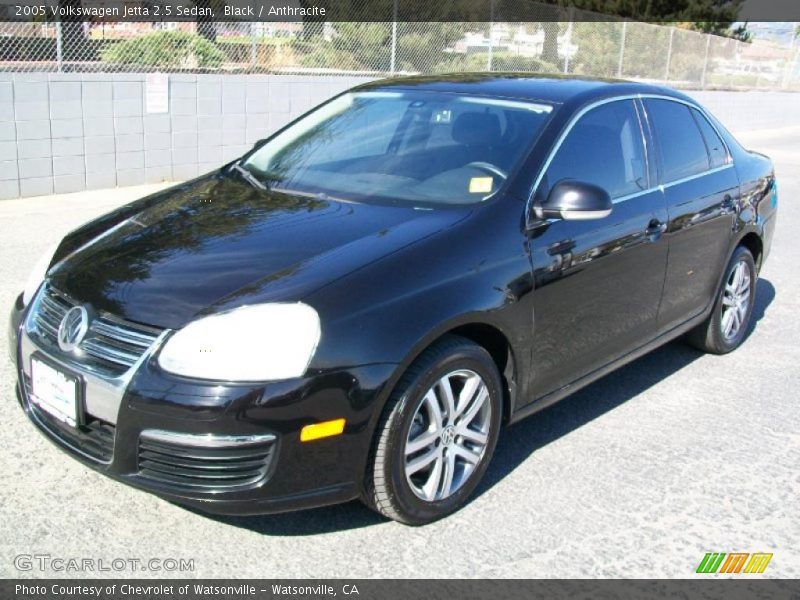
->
[{"left": 644, "top": 98, "right": 739, "bottom": 333}]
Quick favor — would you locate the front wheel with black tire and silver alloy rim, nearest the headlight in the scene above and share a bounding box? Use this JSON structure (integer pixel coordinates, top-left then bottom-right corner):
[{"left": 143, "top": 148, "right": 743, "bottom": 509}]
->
[{"left": 363, "top": 335, "right": 503, "bottom": 525}]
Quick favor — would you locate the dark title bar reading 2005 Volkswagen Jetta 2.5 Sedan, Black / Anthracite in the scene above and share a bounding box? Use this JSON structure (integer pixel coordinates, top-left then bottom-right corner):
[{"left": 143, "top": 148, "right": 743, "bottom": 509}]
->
[{"left": 0, "top": 0, "right": 800, "bottom": 23}]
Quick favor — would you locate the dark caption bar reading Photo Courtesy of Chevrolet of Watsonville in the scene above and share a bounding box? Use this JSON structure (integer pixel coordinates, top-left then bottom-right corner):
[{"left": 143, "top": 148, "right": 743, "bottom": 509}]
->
[{"left": 0, "top": 575, "right": 800, "bottom": 600}]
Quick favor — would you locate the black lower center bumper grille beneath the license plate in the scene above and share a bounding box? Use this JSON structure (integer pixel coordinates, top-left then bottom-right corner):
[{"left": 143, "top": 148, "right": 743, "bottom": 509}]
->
[{"left": 23, "top": 375, "right": 116, "bottom": 463}]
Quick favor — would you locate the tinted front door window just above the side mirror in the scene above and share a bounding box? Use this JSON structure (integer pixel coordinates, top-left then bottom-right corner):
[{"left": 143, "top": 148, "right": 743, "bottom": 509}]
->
[{"left": 538, "top": 100, "right": 648, "bottom": 201}]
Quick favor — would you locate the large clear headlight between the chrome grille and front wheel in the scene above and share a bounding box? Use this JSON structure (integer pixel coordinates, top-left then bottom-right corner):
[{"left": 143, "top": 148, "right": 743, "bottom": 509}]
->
[{"left": 158, "top": 303, "right": 320, "bottom": 381}]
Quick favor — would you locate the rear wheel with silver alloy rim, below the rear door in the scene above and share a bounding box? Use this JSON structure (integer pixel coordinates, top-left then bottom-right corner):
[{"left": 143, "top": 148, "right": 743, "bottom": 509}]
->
[{"left": 686, "top": 246, "right": 758, "bottom": 354}]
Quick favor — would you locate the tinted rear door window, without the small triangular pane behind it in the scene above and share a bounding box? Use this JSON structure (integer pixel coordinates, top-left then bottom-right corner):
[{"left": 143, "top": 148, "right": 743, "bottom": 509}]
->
[{"left": 647, "top": 100, "right": 709, "bottom": 183}]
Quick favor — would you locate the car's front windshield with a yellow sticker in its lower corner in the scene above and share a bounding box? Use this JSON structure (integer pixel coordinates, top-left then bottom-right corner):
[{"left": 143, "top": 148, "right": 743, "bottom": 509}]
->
[{"left": 242, "top": 91, "right": 552, "bottom": 204}]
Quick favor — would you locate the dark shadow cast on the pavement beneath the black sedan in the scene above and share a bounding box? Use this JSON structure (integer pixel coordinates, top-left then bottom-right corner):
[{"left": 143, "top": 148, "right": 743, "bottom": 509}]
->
[{"left": 193, "top": 279, "right": 775, "bottom": 536}]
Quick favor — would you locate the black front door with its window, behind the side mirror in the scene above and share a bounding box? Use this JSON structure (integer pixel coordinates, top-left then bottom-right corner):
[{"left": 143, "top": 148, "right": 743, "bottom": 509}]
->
[{"left": 530, "top": 99, "right": 667, "bottom": 396}]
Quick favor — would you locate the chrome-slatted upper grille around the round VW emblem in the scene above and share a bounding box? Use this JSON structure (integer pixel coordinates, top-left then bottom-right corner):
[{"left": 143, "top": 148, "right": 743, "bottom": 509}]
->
[{"left": 30, "top": 285, "right": 161, "bottom": 377}]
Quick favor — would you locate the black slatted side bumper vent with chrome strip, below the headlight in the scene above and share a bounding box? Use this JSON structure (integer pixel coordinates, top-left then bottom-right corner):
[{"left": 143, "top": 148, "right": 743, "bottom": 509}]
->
[{"left": 139, "top": 436, "right": 275, "bottom": 492}]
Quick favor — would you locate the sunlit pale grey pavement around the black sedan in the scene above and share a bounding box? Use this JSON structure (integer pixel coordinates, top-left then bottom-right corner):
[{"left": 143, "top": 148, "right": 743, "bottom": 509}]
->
[{"left": 0, "top": 128, "right": 800, "bottom": 578}]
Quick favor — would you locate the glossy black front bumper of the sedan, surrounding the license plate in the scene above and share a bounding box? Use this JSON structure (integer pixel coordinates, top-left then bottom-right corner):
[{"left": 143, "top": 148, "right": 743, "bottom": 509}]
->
[{"left": 9, "top": 301, "right": 396, "bottom": 514}]
